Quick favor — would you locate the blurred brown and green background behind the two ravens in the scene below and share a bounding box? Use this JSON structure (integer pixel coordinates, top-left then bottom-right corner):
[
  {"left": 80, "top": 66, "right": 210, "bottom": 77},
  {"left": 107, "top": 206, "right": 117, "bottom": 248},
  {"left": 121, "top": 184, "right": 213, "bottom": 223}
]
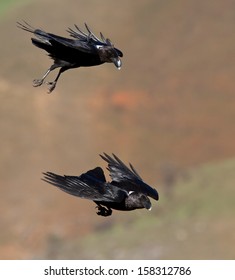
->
[{"left": 0, "top": 0, "right": 235, "bottom": 259}]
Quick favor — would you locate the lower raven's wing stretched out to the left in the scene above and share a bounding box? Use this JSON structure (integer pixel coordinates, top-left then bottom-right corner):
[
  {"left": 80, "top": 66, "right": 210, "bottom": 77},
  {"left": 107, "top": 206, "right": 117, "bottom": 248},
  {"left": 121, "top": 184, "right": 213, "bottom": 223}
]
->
[{"left": 42, "top": 167, "right": 127, "bottom": 202}]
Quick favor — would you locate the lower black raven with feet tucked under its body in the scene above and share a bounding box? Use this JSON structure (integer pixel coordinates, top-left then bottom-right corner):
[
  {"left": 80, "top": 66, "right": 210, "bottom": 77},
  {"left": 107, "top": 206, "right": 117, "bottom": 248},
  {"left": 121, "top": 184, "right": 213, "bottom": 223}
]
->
[{"left": 42, "top": 153, "right": 158, "bottom": 216}]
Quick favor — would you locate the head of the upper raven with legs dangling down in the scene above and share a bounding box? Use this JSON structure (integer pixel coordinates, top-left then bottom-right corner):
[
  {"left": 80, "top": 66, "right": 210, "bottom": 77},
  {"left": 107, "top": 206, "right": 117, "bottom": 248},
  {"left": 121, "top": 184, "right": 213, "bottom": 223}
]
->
[{"left": 96, "top": 39, "right": 123, "bottom": 70}]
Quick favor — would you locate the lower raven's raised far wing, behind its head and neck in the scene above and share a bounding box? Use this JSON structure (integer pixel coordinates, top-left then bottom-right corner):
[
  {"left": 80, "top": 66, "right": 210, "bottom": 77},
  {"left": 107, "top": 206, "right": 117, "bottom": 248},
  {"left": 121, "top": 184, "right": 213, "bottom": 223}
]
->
[{"left": 100, "top": 153, "right": 159, "bottom": 200}]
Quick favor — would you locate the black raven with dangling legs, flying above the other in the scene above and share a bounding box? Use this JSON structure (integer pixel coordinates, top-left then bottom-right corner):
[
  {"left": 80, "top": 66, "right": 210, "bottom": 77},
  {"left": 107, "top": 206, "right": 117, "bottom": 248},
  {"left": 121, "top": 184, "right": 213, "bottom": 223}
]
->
[{"left": 17, "top": 22, "right": 123, "bottom": 93}]
